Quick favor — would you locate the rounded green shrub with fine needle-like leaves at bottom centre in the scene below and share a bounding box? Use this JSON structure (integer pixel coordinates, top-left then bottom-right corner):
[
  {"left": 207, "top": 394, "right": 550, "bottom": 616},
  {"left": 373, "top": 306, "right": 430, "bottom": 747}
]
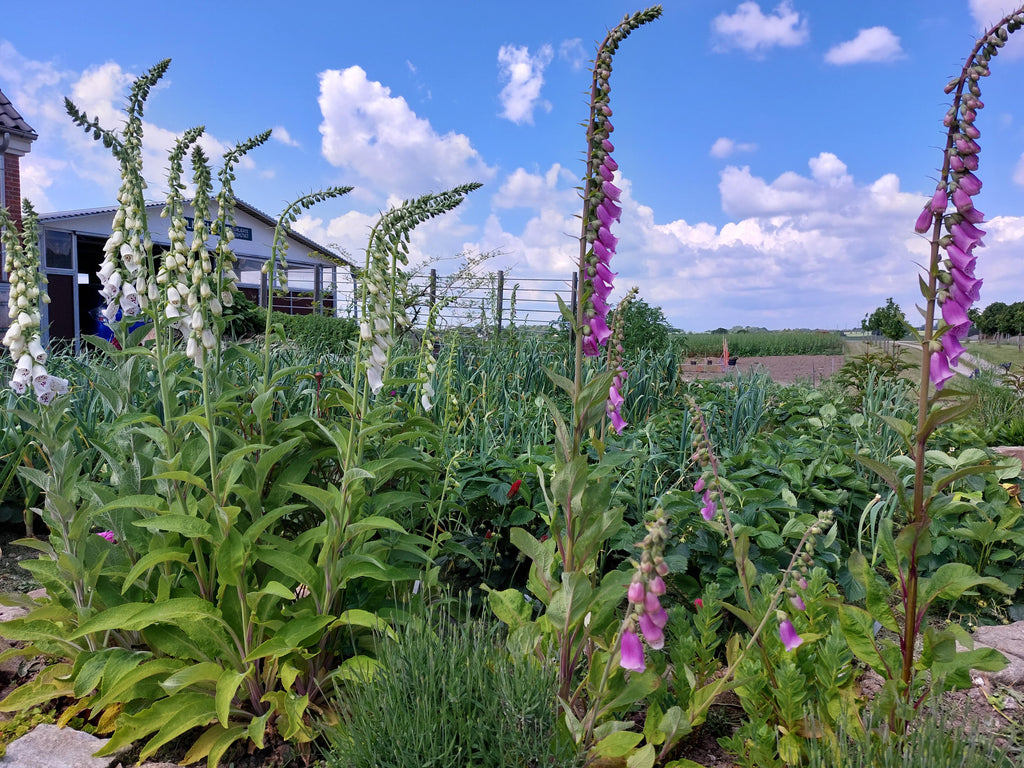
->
[{"left": 326, "top": 612, "right": 577, "bottom": 768}]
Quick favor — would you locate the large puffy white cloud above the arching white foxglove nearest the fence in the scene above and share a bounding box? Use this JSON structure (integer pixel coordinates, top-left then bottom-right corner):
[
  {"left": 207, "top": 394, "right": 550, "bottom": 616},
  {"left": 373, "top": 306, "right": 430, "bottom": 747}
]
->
[{"left": 319, "top": 67, "right": 494, "bottom": 197}]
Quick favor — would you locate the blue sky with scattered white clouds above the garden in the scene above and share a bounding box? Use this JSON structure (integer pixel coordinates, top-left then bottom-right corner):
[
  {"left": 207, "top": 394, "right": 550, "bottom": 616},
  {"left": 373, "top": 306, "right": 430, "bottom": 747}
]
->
[{"left": 0, "top": 0, "right": 1024, "bottom": 331}]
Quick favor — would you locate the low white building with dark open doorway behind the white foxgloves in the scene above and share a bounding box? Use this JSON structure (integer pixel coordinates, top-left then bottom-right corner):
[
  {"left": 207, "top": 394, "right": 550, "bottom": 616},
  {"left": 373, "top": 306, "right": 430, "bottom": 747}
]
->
[{"left": 39, "top": 200, "right": 354, "bottom": 348}]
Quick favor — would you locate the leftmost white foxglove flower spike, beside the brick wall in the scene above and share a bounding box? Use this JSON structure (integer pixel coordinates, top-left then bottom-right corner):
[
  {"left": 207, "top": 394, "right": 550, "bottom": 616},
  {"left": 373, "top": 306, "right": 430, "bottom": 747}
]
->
[{"left": 0, "top": 200, "right": 68, "bottom": 406}]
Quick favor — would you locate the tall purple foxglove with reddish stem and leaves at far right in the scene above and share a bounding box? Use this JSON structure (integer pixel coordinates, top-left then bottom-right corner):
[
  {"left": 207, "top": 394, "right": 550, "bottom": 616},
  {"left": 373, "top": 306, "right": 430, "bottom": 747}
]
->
[{"left": 841, "top": 6, "right": 1024, "bottom": 727}]
